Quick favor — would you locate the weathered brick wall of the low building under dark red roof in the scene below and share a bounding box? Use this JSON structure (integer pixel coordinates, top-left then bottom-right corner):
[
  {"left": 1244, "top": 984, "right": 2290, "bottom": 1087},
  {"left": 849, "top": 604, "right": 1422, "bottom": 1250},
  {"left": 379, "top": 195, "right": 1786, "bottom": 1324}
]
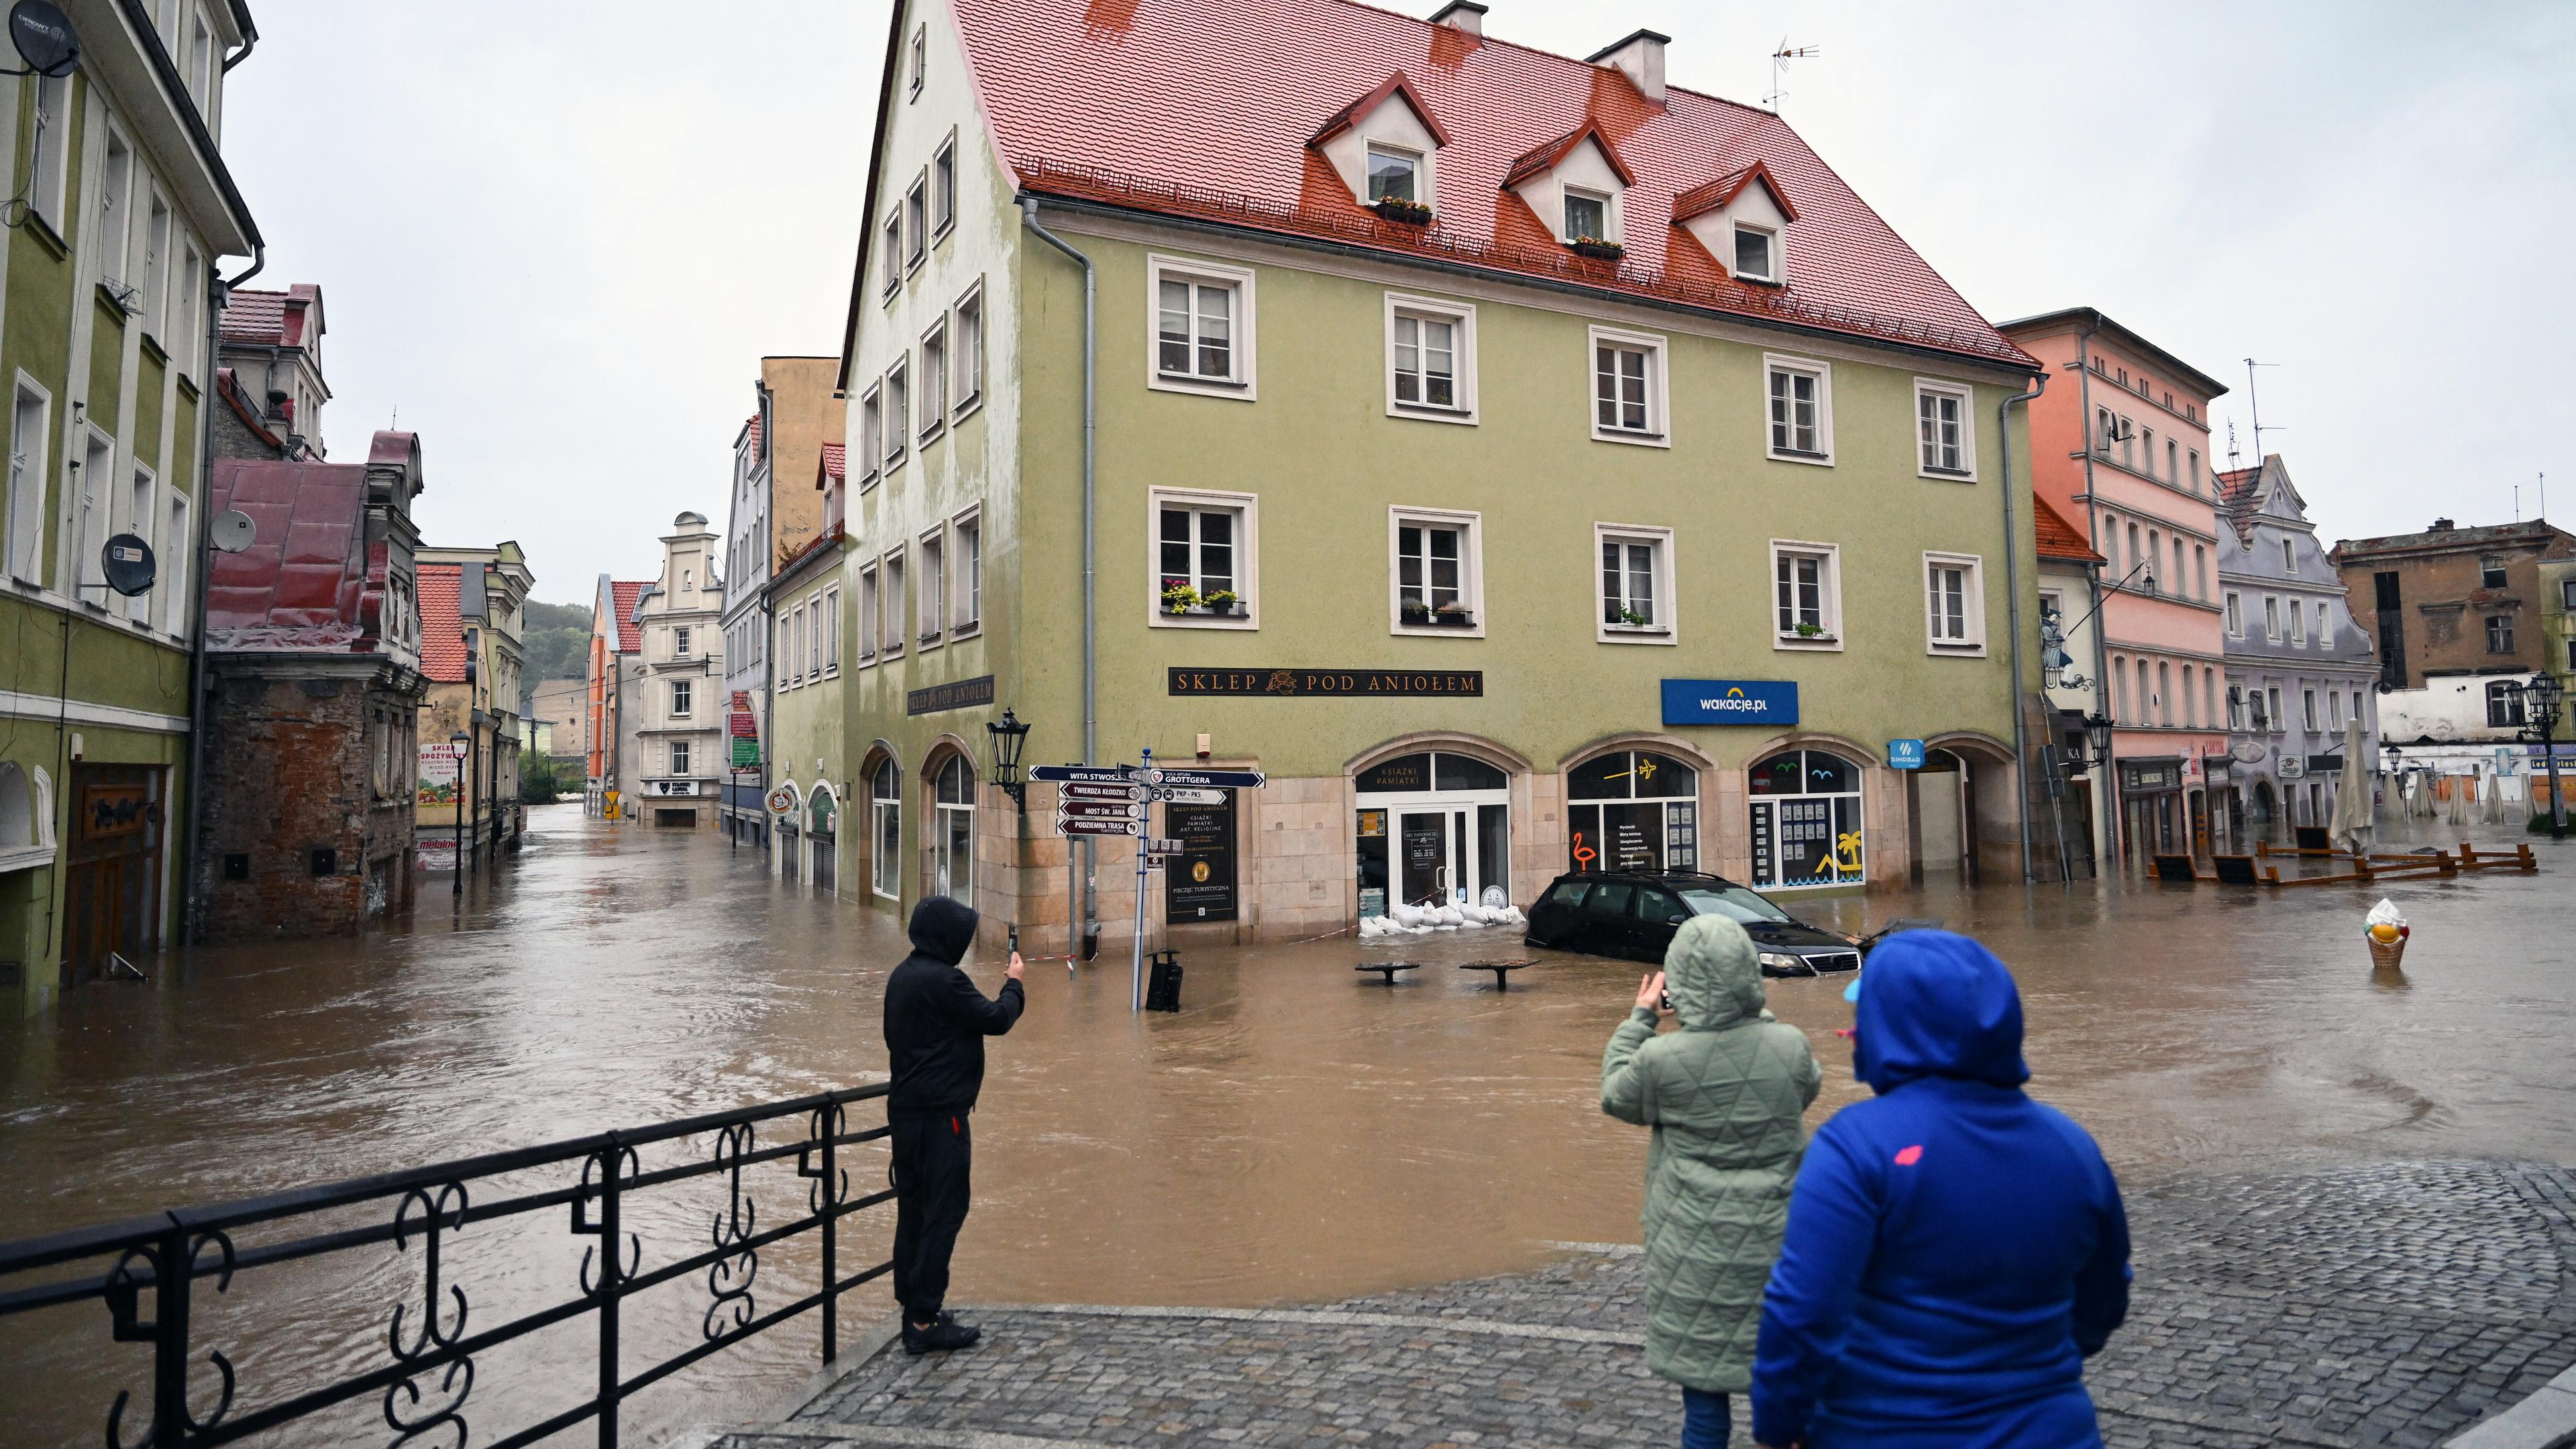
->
[{"left": 196, "top": 660, "right": 417, "bottom": 944}]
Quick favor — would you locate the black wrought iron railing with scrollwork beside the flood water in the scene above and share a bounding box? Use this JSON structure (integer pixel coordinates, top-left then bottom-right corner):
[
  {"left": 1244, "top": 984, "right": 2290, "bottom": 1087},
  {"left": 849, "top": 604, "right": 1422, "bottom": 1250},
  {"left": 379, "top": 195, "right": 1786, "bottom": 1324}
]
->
[{"left": 0, "top": 1083, "right": 894, "bottom": 1449}]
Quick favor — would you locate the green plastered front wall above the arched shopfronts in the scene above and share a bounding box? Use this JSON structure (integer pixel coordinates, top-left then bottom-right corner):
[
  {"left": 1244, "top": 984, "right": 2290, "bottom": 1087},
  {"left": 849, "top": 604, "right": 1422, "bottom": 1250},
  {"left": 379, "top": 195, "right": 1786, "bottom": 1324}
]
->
[{"left": 994, "top": 227, "right": 2033, "bottom": 776}]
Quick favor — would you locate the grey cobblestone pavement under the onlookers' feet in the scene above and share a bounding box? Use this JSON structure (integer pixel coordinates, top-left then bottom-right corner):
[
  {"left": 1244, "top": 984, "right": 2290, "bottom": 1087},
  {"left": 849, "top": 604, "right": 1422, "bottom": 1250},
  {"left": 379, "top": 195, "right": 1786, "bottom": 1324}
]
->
[{"left": 716, "top": 1163, "right": 2576, "bottom": 1449}]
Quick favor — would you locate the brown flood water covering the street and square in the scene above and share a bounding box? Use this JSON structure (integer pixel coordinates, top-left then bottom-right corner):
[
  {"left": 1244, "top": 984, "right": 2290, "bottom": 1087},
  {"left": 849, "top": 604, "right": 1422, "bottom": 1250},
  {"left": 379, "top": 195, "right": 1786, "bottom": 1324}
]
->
[{"left": 0, "top": 807, "right": 2576, "bottom": 1444}]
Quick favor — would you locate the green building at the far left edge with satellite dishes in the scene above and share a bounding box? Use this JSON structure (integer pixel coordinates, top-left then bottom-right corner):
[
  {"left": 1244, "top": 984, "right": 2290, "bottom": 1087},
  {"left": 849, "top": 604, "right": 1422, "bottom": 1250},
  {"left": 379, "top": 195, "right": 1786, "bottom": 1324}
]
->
[{"left": 0, "top": 0, "right": 260, "bottom": 1011}]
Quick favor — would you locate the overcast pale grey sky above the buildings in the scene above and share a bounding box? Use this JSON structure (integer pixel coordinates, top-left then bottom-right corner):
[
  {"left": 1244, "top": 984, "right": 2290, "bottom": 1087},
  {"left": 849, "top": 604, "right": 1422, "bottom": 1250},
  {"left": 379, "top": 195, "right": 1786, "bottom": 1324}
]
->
[{"left": 224, "top": 0, "right": 2576, "bottom": 603}]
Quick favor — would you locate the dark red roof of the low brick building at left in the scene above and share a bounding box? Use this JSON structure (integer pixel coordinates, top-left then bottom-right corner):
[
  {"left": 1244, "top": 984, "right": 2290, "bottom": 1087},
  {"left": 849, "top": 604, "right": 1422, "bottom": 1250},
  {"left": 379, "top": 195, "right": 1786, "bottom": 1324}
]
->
[{"left": 206, "top": 459, "right": 371, "bottom": 650}]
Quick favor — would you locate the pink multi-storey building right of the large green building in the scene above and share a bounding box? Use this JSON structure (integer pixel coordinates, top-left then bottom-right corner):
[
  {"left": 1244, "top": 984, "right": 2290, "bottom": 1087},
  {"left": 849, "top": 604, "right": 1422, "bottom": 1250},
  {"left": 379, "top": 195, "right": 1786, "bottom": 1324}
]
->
[{"left": 2002, "top": 307, "right": 2231, "bottom": 864}]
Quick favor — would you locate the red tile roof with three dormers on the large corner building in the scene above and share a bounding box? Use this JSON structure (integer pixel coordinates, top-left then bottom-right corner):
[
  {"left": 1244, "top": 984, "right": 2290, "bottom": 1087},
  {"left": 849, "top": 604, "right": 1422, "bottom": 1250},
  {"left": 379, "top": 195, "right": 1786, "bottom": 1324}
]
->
[{"left": 956, "top": 0, "right": 2035, "bottom": 366}]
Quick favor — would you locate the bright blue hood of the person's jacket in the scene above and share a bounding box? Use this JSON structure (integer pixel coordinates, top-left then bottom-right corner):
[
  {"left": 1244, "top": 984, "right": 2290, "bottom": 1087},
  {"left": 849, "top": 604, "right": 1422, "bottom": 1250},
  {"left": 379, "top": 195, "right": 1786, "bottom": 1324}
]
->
[{"left": 1852, "top": 930, "right": 2030, "bottom": 1093}]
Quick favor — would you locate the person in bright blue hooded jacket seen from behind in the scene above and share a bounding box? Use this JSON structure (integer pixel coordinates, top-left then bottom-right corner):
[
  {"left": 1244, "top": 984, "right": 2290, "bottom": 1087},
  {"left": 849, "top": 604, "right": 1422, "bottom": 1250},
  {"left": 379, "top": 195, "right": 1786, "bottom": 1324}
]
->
[{"left": 1752, "top": 930, "right": 2128, "bottom": 1449}]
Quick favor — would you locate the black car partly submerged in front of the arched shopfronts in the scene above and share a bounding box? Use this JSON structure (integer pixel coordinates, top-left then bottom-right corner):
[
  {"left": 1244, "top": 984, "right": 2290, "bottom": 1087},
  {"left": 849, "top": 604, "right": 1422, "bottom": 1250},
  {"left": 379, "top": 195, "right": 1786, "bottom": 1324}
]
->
[{"left": 1527, "top": 871, "right": 1860, "bottom": 977}]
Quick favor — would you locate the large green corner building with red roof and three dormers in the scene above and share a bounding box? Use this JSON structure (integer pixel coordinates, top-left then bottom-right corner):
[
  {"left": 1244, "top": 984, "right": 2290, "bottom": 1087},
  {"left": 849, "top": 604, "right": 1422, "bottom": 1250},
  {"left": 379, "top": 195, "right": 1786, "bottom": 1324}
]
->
[{"left": 804, "top": 0, "right": 2037, "bottom": 944}]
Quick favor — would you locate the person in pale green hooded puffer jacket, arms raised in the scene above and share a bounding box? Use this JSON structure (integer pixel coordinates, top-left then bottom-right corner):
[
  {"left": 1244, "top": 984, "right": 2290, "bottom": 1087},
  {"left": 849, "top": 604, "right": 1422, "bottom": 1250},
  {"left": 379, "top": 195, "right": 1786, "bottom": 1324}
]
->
[{"left": 1602, "top": 915, "right": 1824, "bottom": 1449}]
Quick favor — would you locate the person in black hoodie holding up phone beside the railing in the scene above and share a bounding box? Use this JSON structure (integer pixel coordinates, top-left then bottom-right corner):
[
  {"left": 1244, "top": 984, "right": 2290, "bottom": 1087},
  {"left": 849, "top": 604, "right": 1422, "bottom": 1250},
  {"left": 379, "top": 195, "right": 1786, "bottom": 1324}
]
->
[{"left": 886, "top": 895, "right": 1028, "bottom": 1354}]
